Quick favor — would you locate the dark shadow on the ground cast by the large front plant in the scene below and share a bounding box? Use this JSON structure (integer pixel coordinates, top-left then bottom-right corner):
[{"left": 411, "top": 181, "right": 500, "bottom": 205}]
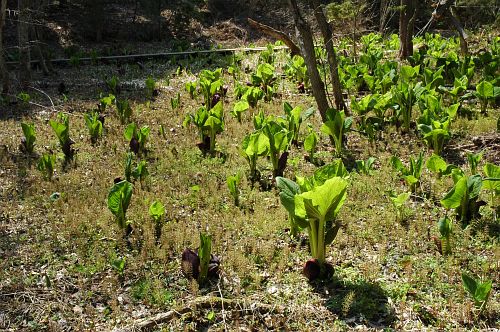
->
[{"left": 312, "top": 275, "right": 395, "bottom": 328}]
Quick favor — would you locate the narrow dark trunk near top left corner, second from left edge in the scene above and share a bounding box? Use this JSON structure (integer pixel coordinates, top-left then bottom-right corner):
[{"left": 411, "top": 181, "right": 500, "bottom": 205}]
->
[{"left": 17, "top": 0, "right": 31, "bottom": 89}]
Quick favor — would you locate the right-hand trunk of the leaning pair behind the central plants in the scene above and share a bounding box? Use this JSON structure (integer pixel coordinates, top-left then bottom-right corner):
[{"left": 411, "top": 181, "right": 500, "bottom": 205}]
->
[{"left": 312, "top": 0, "right": 350, "bottom": 115}]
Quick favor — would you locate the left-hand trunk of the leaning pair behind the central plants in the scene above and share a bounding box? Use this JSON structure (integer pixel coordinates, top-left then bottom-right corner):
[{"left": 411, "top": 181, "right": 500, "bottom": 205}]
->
[{"left": 288, "top": 0, "right": 329, "bottom": 122}]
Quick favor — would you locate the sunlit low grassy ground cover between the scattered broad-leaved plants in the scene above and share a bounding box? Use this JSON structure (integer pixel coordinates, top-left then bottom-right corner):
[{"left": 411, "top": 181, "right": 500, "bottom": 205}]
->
[{"left": 0, "top": 33, "right": 500, "bottom": 330}]
